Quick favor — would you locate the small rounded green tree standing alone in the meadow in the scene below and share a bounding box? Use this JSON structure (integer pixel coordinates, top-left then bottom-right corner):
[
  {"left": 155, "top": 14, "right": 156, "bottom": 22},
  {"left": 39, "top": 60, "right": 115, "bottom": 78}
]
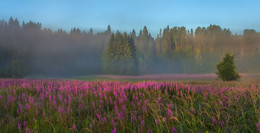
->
[{"left": 216, "top": 53, "right": 240, "bottom": 81}]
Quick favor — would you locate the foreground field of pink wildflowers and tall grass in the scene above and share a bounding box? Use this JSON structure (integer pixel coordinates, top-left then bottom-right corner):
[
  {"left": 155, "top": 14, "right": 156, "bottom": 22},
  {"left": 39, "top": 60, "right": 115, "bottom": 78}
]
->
[{"left": 0, "top": 79, "right": 260, "bottom": 133}]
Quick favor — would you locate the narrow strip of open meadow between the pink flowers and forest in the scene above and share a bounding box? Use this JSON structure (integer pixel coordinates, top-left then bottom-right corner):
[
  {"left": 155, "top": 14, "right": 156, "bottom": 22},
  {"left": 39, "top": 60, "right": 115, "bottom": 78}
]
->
[{"left": 71, "top": 73, "right": 260, "bottom": 88}]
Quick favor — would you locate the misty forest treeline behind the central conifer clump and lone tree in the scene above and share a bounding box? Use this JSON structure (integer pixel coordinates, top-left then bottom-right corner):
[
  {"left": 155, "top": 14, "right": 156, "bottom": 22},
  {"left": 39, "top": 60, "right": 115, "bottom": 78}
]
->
[{"left": 0, "top": 18, "right": 260, "bottom": 77}]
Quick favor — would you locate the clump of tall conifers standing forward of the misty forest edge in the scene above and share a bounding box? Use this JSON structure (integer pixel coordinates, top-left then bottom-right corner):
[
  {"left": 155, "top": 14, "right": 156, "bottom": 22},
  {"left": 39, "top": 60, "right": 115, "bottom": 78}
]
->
[{"left": 104, "top": 32, "right": 138, "bottom": 75}]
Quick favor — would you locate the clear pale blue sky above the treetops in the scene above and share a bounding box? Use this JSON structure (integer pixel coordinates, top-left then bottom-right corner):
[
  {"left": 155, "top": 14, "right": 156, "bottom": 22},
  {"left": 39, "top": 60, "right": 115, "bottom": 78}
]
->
[{"left": 0, "top": 0, "right": 260, "bottom": 36}]
